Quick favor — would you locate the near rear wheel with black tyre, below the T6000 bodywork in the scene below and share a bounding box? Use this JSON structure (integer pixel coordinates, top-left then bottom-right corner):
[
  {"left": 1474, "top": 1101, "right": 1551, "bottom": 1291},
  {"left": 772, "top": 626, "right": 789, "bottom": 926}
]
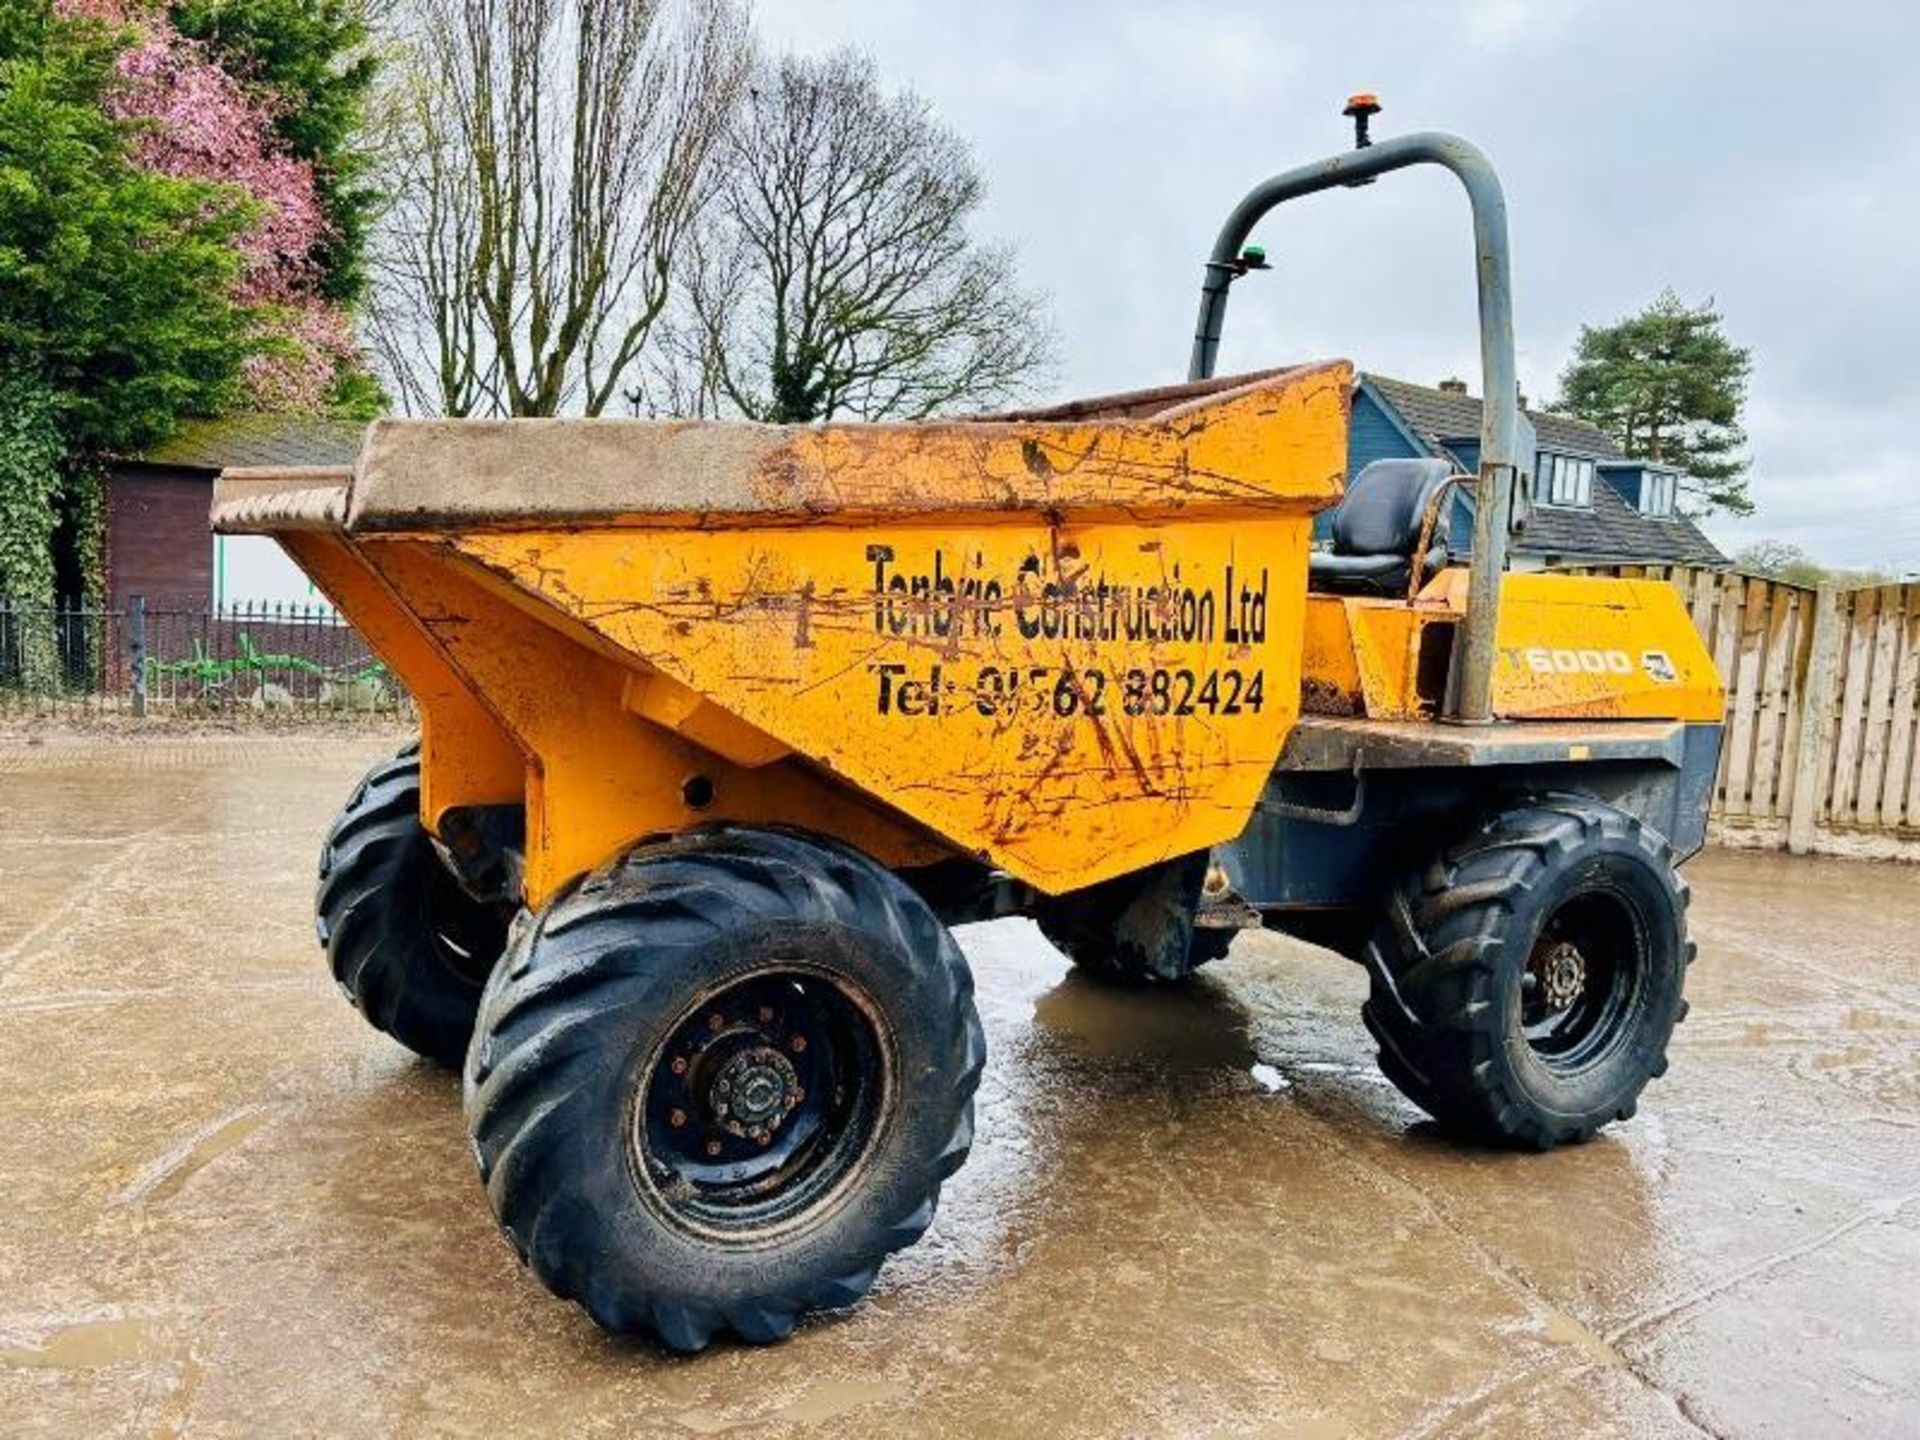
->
[{"left": 1363, "top": 795, "right": 1693, "bottom": 1150}]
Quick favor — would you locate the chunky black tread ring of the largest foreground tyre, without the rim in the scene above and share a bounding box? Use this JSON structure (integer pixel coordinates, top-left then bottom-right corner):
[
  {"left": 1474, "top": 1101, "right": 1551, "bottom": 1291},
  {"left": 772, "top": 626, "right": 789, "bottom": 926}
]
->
[{"left": 465, "top": 828, "right": 987, "bottom": 1352}]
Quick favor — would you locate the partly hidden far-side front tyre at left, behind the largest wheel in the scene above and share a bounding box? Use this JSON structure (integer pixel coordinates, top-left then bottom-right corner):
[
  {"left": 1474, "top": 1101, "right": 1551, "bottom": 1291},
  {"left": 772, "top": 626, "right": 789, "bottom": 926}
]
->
[{"left": 315, "top": 741, "right": 507, "bottom": 1068}]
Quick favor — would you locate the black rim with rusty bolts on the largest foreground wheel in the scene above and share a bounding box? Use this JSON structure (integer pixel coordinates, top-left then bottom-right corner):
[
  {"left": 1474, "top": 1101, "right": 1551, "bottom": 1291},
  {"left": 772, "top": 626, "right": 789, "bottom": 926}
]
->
[{"left": 632, "top": 966, "right": 891, "bottom": 1242}]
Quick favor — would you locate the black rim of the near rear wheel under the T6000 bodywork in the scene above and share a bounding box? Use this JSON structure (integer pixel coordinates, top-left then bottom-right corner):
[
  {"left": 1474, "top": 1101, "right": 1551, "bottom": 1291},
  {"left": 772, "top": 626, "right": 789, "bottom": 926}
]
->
[{"left": 1521, "top": 889, "right": 1647, "bottom": 1075}]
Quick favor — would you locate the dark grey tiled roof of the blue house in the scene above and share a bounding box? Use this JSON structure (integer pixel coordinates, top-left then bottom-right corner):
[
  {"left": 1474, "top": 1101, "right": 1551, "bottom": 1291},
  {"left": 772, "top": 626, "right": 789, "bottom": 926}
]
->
[{"left": 1367, "top": 374, "right": 1728, "bottom": 564}]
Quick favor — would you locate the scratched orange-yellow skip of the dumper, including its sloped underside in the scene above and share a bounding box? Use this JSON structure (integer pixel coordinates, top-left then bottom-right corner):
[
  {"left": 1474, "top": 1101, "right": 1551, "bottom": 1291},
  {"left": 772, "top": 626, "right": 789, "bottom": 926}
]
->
[{"left": 236, "top": 363, "right": 1352, "bottom": 904}]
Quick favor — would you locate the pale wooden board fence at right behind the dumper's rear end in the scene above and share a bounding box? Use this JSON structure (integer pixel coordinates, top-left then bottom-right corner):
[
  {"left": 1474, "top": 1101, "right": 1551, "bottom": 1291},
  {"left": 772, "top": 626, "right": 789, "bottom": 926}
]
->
[{"left": 1590, "top": 564, "right": 1920, "bottom": 856}]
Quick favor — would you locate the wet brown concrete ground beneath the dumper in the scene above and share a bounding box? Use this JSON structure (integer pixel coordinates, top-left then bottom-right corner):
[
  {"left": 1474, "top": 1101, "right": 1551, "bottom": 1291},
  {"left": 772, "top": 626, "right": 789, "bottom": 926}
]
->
[{"left": 0, "top": 735, "right": 1920, "bottom": 1436}]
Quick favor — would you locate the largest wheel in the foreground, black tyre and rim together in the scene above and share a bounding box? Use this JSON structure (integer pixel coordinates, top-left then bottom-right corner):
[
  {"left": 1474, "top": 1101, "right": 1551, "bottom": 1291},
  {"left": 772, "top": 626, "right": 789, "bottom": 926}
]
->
[{"left": 467, "top": 828, "right": 985, "bottom": 1352}]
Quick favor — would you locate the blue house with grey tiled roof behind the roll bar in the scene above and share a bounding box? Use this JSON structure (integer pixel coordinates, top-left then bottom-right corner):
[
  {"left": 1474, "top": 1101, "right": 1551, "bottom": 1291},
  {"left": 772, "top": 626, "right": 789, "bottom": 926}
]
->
[{"left": 1348, "top": 374, "right": 1730, "bottom": 570}]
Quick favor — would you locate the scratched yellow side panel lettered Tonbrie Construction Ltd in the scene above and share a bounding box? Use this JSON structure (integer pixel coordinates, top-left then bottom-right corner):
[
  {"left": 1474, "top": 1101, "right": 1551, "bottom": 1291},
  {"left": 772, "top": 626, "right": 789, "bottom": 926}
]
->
[{"left": 453, "top": 511, "right": 1308, "bottom": 902}]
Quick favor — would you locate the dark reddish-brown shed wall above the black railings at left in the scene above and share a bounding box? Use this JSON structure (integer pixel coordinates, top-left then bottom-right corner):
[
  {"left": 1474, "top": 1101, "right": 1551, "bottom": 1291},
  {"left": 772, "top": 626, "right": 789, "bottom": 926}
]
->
[{"left": 106, "top": 465, "right": 213, "bottom": 611}]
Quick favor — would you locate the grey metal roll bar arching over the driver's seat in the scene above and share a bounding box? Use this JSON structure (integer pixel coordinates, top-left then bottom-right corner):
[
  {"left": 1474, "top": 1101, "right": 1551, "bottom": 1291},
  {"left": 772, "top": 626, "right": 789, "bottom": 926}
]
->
[{"left": 1187, "top": 131, "right": 1521, "bottom": 724}]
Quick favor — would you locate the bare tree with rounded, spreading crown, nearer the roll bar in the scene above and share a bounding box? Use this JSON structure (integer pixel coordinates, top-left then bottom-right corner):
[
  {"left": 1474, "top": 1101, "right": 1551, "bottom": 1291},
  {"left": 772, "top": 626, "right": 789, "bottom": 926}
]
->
[{"left": 652, "top": 50, "right": 1052, "bottom": 422}]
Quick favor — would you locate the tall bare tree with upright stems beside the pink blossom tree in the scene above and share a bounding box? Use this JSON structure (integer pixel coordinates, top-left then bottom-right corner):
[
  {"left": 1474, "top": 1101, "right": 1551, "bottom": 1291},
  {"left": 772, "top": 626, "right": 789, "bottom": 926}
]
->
[{"left": 372, "top": 0, "right": 751, "bottom": 415}]
